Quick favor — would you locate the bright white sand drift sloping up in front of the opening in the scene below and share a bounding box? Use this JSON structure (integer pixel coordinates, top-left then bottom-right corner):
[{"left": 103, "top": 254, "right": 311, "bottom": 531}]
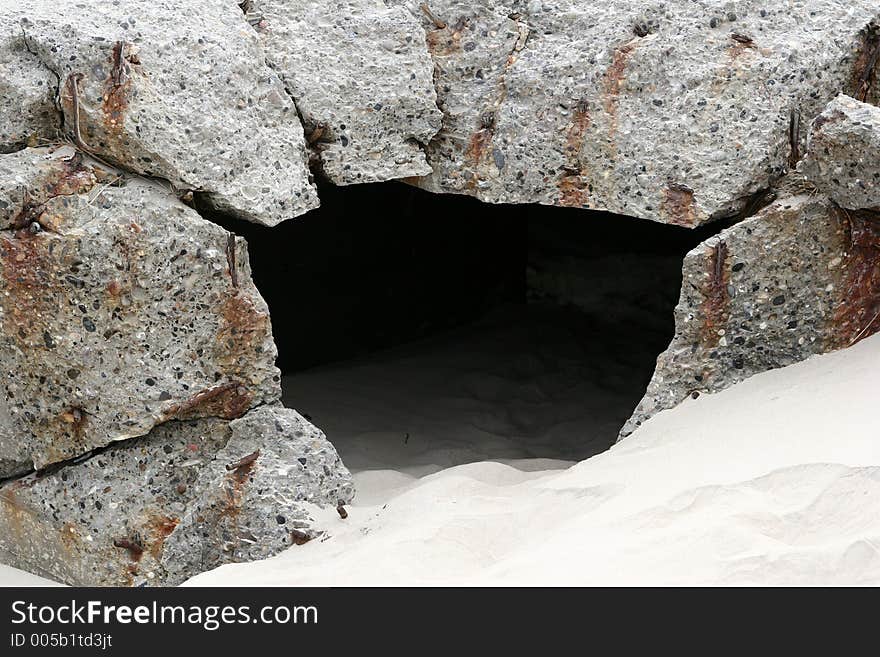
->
[{"left": 0, "top": 322, "right": 880, "bottom": 586}]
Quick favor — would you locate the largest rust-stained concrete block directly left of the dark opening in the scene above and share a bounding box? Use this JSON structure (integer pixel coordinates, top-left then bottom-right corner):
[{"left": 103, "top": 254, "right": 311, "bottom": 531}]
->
[{"left": 0, "top": 149, "right": 280, "bottom": 476}]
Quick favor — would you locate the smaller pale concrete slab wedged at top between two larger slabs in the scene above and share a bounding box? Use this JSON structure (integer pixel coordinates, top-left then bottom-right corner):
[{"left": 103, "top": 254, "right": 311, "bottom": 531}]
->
[{"left": 249, "top": 0, "right": 442, "bottom": 185}]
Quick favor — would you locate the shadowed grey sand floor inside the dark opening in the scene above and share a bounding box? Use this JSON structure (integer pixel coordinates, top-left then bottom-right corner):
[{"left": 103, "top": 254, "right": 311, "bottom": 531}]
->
[{"left": 284, "top": 306, "right": 669, "bottom": 477}]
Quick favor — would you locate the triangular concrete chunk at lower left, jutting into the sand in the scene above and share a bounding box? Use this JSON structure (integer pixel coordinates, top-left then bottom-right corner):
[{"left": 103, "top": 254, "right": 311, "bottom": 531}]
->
[{"left": 163, "top": 407, "right": 354, "bottom": 581}]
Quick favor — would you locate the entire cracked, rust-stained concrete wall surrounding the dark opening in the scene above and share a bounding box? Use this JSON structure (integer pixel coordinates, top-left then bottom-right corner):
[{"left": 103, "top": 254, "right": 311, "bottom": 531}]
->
[{"left": 0, "top": 0, "right": 880, "bottom": 586}]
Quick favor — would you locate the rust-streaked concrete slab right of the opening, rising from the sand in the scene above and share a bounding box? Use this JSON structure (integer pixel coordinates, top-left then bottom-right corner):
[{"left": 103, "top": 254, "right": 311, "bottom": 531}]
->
[{"left": 620, "top": 193, "right": 880, "bottom": 437}]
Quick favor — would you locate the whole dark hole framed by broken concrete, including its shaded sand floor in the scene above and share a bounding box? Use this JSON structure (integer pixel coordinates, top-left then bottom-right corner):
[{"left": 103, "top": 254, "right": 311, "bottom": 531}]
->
[{"left": 210, "top": 182, "right": 718, "bottom": 474}]
